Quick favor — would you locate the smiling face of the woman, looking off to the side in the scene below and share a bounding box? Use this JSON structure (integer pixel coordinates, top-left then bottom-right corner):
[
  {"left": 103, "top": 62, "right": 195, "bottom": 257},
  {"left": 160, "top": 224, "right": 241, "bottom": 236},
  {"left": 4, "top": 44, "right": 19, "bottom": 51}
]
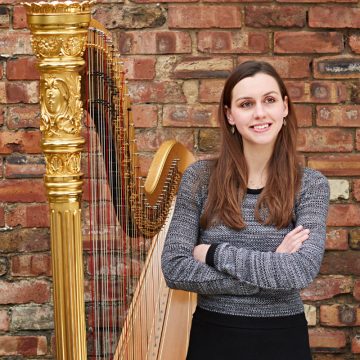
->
[{"left": 227, "top": 73, "right": 288, "bottom": 152}]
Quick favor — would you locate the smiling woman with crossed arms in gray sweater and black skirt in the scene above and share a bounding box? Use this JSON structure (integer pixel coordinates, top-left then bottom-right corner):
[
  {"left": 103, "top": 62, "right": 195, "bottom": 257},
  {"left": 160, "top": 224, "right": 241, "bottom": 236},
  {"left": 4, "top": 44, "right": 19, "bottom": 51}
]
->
[{"left": 162, "top": 61, "right": 329, "bottom": 360}]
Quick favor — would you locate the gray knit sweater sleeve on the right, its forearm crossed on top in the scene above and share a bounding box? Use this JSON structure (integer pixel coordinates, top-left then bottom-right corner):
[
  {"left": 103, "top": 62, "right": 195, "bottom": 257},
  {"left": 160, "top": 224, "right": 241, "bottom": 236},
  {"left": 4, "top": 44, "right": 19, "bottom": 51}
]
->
[{"left": 214, "top": 169, "right": 329, "bottom": 290}]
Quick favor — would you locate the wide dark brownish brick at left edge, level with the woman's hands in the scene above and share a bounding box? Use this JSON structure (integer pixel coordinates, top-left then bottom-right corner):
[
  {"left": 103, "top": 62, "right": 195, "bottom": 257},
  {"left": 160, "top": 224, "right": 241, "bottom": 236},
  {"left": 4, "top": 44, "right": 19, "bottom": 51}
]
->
[{"left": 0, "top": 228, "right": 50, "bottom": 253}]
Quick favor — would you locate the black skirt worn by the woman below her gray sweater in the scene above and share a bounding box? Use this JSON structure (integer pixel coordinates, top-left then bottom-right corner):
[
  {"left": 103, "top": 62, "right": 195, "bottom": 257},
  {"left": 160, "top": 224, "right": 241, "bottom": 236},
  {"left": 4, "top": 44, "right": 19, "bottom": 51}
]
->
[{"left": 186, "top": 307, "right": 312, "bottom": 360}]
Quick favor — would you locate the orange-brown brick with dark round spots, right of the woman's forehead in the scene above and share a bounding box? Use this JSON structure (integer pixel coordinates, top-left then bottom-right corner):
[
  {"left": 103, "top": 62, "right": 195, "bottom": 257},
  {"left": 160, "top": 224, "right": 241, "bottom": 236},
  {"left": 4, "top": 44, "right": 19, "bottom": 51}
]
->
[{"left": 285, "top": 80, "right": 349, "bottom": 103}]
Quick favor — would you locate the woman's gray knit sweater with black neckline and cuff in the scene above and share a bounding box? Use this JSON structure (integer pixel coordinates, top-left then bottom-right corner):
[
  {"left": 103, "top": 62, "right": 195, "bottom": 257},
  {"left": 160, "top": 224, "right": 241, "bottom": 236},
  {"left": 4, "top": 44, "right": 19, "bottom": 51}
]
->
[{"left": 162, "top": 161, "right": 329, "bottom": 317}]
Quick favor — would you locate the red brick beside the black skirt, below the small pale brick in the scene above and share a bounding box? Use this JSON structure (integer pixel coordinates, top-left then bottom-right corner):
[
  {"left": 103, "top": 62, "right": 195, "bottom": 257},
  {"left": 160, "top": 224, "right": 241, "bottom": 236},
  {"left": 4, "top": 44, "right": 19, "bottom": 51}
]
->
[{"left": 309, "top": 328, "right": 346, "bottom": 351}]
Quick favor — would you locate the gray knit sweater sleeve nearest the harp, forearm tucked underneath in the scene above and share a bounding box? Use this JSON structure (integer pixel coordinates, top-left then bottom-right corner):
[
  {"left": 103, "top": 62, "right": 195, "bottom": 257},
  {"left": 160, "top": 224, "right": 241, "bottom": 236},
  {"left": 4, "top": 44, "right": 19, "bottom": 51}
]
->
[{"left": 161, "top": 163, "right": 259, "bottom": 295}]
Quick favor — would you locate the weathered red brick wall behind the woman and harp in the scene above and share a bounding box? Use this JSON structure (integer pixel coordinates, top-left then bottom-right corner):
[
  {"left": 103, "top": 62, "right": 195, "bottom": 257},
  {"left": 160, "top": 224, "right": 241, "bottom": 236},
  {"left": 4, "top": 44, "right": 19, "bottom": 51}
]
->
[{"left": 0, "top": 0, "right": 360, "bottom": 360}]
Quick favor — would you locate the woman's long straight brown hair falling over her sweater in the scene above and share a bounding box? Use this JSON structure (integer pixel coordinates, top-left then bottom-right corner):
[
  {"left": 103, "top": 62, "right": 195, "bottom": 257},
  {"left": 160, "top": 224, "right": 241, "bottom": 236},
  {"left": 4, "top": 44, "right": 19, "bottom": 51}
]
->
[{"left": 201, "top": 61, "right": 301, "bottom": 229}]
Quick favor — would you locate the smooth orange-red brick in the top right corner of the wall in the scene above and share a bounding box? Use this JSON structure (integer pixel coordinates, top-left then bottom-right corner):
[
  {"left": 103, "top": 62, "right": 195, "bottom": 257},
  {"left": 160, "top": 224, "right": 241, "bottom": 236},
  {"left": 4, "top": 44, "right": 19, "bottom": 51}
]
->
[{"left": 309, "top": 5, "right": 360, "bottom": 29}]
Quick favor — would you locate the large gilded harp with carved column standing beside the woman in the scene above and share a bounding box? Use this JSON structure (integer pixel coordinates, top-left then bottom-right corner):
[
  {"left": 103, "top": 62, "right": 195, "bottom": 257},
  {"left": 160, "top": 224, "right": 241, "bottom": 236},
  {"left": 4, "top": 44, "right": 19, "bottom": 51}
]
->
[{"left": 24, "top": 1, "right": 195, "bottom": 360}]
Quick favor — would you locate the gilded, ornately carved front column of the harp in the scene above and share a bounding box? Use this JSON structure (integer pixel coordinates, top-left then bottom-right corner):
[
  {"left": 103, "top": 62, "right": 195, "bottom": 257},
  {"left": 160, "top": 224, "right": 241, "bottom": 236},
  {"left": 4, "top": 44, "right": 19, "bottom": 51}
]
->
[{"left": 24, "top": 1, "right": 91, "bottom": 360}]
